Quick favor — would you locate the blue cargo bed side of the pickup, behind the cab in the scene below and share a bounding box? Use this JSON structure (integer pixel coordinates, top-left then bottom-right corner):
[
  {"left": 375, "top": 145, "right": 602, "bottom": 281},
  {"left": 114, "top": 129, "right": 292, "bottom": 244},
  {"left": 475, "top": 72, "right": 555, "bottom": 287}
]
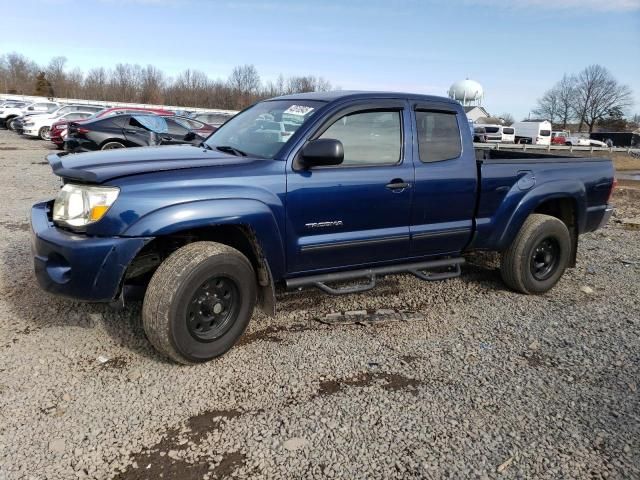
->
[{"left": 472, "top": 149, "right": 614, "bottom": 250}]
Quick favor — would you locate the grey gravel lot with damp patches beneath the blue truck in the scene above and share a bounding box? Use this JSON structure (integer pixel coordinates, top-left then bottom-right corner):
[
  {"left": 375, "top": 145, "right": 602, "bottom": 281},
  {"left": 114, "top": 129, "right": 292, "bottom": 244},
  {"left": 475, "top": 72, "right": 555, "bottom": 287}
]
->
[{"left": 0, "top": 130, "right": 640, "bottom": 480}]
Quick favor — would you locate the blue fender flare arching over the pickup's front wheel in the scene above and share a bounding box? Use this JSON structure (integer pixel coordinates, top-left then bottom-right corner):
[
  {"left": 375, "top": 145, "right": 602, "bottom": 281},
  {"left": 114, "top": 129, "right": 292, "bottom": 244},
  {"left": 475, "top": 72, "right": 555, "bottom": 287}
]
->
[{"left": 122, "top": 198, "right": 285, "bottom": 283}]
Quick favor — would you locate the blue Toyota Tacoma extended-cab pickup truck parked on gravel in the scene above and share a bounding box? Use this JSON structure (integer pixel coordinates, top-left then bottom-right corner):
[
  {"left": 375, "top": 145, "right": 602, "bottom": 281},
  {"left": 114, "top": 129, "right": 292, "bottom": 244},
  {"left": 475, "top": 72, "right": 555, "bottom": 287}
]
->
[{"left": 31, "top": 92, "right": 614, "bottom": 363}]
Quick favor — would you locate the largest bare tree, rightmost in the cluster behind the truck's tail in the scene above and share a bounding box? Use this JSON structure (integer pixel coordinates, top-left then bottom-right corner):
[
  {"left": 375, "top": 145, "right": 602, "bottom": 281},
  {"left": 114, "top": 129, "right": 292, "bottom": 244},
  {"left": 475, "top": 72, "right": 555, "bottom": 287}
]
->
[{"left": 574, "top": 65, "right": 633, "bottom": 132}]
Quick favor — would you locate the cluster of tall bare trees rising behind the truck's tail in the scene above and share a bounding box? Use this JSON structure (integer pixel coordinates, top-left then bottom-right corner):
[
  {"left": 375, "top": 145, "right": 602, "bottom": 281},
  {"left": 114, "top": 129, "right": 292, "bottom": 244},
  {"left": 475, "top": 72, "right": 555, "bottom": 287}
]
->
[{"left": 533, "top": 65, "right": 633, "bottom": 132}]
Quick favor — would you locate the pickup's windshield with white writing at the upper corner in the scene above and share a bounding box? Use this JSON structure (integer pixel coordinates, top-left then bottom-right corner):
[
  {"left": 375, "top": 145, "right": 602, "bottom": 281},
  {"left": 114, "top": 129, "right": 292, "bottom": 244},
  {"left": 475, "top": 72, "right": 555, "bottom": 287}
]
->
[{"left": 205, "top": 100, "right": 324, "bottom": 158}]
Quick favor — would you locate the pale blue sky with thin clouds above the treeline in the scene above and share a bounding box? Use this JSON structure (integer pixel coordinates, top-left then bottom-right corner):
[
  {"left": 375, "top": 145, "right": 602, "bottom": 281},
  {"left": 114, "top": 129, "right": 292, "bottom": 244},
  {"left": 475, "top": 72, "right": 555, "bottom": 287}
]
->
[{"left": 0, "top": 0, "right": 640, "bottom": 119}]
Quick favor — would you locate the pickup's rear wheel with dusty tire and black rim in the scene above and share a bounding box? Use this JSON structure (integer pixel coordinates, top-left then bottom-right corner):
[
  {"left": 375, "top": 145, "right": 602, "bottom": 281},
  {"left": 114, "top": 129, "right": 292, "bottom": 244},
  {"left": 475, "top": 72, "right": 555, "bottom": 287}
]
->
[{"left": 500, "top": 213, "right": 572, "bottom": 294}]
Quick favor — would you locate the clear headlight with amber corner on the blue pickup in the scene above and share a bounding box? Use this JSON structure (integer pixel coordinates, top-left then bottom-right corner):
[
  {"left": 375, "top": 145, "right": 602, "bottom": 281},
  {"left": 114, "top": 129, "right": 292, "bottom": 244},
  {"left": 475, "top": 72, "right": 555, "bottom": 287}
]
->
[{"left": 53, "top": 183, "right": 120, "bottom": 228}]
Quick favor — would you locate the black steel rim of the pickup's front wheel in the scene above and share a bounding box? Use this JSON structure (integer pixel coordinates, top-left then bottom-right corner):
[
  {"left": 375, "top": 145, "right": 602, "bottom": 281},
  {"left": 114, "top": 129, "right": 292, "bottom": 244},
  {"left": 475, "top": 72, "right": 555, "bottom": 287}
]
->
[{"left": 187, "top": 277, "right": 240, "bottom": 342}]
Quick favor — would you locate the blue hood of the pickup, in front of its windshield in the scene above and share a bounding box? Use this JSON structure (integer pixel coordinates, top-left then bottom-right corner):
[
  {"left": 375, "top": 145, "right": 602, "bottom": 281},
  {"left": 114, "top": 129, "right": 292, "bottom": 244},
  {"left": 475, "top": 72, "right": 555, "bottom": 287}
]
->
[{"left": 47, "top": 145, "right": 272, "bottom": 183}]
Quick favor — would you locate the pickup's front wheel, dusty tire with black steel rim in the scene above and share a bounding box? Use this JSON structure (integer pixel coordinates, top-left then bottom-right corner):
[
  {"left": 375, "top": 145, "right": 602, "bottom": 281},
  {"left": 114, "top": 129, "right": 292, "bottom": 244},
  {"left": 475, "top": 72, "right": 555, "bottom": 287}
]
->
[{"left": 142, "top": 242, "right": 257, "bottom": 364}]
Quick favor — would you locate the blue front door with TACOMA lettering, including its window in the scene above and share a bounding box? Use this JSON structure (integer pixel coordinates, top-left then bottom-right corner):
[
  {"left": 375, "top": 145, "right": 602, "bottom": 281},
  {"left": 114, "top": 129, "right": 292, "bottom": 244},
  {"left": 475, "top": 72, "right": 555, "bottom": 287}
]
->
[{"left": 286, "top": 100, "right": 414, "bottom": 273}]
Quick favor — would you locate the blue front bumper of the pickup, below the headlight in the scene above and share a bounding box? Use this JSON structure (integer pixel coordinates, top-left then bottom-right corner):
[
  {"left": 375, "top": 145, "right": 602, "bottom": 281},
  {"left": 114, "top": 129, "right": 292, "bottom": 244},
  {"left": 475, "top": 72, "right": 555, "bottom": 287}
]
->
[{"left": 31, "top": 203, "right": 152, "bottom": 302}]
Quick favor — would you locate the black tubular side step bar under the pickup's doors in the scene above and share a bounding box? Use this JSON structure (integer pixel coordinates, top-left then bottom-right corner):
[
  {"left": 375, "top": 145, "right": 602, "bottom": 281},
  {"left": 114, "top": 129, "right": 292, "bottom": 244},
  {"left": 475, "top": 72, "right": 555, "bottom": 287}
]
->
[{"left": 285, "top": 258, "right": 464, "bottom": 295}]
